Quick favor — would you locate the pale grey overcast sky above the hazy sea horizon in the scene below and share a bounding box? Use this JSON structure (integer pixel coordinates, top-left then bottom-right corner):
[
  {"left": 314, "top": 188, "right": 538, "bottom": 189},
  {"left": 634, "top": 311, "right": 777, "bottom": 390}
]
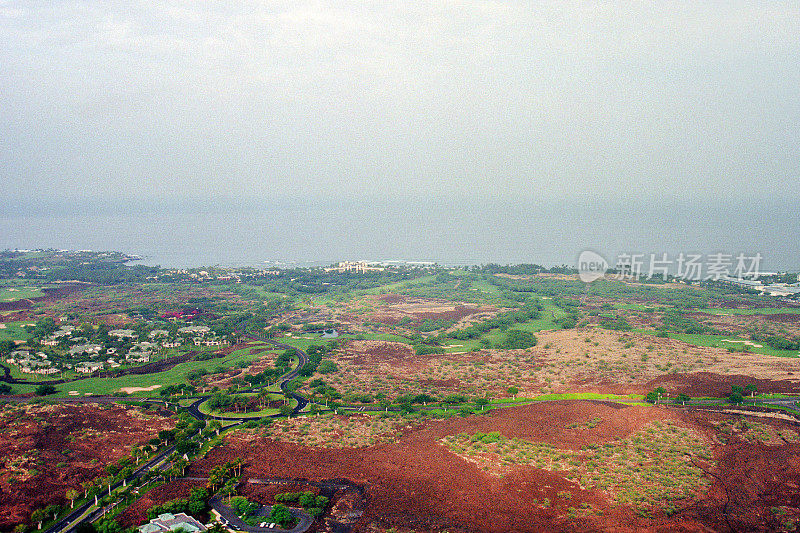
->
[{"left": 0, "top": 0, "right": 800, "bottom": 204}]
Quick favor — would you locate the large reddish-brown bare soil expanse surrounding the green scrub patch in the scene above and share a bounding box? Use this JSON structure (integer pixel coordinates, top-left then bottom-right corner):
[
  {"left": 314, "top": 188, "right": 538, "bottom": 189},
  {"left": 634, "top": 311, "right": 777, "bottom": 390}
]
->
[{"left": 188, "top": 402, "right": 800, "bottom": 532}]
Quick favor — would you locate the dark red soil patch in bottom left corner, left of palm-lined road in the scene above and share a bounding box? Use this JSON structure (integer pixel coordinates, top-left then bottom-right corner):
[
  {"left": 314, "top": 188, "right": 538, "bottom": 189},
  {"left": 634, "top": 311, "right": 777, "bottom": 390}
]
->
[{"left": 0, "top": 404, "right": 174, "bottom": 531}]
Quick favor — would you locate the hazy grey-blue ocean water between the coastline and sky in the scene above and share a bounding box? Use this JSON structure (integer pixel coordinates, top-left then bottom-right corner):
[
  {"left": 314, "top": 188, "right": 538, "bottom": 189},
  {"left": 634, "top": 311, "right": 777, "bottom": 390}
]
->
[{"left": 0, "top": 197, "right": 800, "bottom": 271}]
